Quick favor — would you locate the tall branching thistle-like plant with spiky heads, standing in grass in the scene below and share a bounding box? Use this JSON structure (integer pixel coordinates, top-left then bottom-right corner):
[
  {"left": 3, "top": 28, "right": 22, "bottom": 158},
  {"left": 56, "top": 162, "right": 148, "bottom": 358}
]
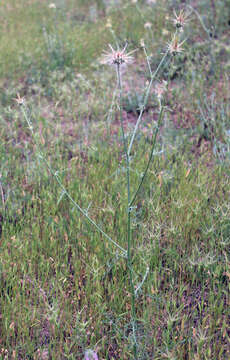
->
[{"left": 15, "top": 9, "right": 189, "bottom": 359}]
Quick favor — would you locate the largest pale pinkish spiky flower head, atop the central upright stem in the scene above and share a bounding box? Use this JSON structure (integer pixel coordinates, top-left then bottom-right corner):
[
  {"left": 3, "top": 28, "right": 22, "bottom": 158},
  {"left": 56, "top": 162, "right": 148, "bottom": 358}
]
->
[{"left": 101, "top": 44, "right": 136, "bottom": 65}]
